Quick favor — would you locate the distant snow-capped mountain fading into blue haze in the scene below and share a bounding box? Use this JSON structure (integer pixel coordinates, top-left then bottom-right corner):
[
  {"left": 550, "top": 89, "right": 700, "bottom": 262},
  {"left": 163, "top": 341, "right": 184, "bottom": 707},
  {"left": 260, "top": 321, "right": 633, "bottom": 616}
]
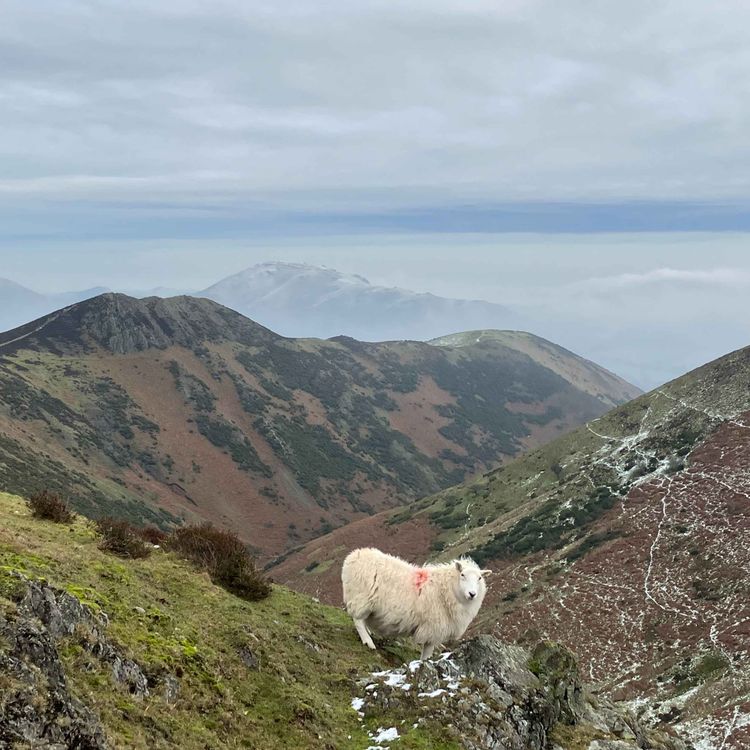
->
[{"left": 197, "top": 263, "right": 519, "bottom": 341}]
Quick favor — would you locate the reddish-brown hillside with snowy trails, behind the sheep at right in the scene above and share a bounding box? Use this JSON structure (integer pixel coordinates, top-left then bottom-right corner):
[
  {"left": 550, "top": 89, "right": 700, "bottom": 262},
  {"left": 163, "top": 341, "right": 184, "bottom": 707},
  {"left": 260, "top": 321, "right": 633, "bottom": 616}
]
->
[{"left": 274, "top": 348, "right": 750, "bottom": 750}]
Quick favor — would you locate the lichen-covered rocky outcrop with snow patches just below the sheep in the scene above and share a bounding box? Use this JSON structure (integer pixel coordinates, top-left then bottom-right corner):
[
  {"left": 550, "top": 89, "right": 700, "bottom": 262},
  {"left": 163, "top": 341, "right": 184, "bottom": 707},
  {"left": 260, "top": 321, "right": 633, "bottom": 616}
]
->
[{"left": 352, "top": 635, "right": 687, "bottom": 750}]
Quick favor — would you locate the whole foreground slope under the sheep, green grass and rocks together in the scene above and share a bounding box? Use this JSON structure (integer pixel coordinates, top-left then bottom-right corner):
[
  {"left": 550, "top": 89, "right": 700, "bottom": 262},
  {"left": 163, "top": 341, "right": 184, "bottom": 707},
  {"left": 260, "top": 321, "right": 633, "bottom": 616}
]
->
[{"left": 0, "top": 493, "right": 685, "bottom": 750}]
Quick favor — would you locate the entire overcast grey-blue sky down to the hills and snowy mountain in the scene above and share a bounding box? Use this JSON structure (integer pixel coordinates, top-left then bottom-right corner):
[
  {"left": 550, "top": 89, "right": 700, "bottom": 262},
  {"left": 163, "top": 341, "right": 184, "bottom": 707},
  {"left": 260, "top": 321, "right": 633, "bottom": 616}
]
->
[{"left": 0, "top": 0, "right": 750, "bottom": 388}]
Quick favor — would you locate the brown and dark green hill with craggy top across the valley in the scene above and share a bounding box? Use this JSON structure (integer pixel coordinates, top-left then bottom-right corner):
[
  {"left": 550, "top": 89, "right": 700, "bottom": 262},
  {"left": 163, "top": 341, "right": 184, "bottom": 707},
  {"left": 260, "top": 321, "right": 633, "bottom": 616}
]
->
[{"left": 0, "top": 294, "right": 636, "bottom": 555}]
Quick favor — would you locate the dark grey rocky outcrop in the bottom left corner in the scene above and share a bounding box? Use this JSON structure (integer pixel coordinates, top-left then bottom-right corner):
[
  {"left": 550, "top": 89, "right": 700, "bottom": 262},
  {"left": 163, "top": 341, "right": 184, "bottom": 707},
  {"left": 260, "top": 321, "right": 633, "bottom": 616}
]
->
[{"left": 0, "top": 575, "right": 154, "bottom": 750}]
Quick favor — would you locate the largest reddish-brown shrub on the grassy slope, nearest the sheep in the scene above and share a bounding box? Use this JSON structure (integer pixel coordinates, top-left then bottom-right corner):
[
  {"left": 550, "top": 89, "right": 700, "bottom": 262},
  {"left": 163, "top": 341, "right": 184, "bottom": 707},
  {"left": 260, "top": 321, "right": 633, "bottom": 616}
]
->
[{"left": 167, "top": 523, "right": 271, "bottom": 602}]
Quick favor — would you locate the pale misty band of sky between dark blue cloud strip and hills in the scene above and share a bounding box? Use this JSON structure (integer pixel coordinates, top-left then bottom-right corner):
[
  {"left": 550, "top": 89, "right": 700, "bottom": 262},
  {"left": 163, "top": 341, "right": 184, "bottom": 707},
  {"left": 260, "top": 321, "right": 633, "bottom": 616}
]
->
[{"left": 0, "top": 242, "right": 750, "bottom": 388}]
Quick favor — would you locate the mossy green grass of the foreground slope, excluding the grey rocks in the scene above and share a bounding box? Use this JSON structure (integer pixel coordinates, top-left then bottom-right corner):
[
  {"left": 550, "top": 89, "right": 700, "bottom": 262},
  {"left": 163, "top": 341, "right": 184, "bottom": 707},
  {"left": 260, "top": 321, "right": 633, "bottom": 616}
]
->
[{"left": 0, "top": 493, "right": 455, "bottom": 750}]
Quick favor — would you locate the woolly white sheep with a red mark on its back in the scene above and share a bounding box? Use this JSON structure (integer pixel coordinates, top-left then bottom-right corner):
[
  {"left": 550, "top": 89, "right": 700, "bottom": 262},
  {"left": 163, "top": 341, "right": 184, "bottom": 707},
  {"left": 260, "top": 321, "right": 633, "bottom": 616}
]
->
[{"left": 341, "top": 547, "right": 491, "bottom": 660}]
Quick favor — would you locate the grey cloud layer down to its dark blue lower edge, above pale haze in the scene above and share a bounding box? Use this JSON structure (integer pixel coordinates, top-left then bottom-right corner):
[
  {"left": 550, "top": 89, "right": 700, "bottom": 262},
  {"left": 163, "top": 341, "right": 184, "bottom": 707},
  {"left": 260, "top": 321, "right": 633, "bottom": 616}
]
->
[{"left": 0, "top": 0, "right": 750, "bottom": 242}]
